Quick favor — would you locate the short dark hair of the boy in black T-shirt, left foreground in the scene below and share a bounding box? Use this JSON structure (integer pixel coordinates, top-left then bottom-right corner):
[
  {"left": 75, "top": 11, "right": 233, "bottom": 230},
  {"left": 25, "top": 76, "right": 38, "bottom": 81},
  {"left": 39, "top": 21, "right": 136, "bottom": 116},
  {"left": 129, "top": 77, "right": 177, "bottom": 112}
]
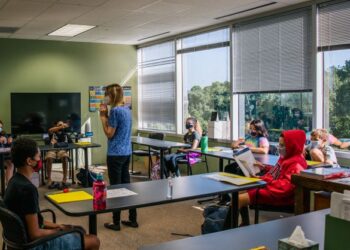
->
[{"left": 11, "top": 138, "right": 38, "bottom": 168}]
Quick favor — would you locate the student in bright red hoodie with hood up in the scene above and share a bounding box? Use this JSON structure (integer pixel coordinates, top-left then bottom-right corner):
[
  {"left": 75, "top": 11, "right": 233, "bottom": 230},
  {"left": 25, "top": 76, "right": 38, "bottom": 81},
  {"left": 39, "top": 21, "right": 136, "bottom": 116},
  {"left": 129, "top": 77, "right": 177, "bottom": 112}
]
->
[{"left": 239, "top": 130, "right": 307, "bottom": 225}]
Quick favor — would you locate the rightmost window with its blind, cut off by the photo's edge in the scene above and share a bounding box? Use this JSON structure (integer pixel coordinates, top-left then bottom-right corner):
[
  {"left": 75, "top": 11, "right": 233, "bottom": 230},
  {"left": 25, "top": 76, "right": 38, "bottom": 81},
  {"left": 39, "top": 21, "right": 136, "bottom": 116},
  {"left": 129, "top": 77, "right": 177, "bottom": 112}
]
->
[{"left": 318, "top": 1, "right": 350, "bottom": 143}]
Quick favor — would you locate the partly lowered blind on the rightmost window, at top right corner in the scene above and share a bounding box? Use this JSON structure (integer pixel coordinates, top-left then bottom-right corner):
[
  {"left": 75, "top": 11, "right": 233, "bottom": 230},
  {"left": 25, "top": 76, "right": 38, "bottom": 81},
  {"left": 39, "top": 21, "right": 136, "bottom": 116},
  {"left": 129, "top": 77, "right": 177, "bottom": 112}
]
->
[{"left": 318, "top": 1, "right": 350, "bottom": 47}]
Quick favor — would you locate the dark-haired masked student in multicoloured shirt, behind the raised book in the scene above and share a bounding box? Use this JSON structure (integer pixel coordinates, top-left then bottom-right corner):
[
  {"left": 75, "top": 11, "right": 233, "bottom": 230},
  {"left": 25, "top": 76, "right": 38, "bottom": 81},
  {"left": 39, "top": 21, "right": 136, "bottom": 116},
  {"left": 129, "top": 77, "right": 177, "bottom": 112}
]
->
[{"left": 231, "top": 120, "right": 270, "bottom": 154}]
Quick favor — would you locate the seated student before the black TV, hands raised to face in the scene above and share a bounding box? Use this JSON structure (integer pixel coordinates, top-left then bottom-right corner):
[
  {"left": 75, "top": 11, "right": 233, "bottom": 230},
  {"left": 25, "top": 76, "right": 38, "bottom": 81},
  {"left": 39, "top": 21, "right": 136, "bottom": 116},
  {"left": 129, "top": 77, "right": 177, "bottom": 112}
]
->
[{"left": 45, "top": 121, "right": 71, "bottom": 189}]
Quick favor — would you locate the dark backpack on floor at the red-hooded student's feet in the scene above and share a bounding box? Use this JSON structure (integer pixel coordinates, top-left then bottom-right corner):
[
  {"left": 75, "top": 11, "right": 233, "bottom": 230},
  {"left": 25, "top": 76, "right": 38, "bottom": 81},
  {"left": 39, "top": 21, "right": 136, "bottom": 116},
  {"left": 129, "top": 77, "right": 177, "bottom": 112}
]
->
[{"left": 201, "top": 205, "right": 229, "bottom": 234}]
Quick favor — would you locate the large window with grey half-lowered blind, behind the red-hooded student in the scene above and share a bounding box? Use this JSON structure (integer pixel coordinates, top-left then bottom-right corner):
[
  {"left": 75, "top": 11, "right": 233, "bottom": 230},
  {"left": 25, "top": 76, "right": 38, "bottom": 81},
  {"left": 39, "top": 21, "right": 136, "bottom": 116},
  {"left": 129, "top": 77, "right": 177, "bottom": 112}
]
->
[{"left": 233, "top": 10, "right": 312, "bottom": 141}]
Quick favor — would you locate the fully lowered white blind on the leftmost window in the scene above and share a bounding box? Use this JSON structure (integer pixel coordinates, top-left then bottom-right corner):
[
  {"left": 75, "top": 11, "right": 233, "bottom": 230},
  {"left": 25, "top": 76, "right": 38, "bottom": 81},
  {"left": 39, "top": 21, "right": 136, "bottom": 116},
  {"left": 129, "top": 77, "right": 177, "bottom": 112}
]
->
[{"left": 138, "top": 41, "right": 176, "bottom": 132}]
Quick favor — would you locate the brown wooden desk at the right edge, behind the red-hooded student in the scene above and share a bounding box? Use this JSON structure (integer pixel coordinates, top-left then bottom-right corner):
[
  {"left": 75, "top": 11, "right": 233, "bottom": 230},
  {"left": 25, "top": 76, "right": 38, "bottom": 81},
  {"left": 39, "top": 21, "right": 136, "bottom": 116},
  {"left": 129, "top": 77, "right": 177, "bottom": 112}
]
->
[{"left": 292, "top": 175, "right": 350, "bottom": 214}]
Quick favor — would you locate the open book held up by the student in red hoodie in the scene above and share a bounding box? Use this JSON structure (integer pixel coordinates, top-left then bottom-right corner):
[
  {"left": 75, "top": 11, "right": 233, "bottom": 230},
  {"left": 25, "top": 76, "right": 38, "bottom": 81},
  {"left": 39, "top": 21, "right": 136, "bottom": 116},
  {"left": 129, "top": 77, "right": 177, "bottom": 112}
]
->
[{"left": 233, "top": 147, "right": 260, "bottom": 177}]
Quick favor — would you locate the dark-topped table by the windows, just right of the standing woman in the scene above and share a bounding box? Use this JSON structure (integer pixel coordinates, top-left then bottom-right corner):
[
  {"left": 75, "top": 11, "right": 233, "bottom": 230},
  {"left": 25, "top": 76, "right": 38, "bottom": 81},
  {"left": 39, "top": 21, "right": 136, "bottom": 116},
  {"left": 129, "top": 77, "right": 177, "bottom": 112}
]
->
[{"left": 131, "top": 136, "right": 191, "bottom": 179}]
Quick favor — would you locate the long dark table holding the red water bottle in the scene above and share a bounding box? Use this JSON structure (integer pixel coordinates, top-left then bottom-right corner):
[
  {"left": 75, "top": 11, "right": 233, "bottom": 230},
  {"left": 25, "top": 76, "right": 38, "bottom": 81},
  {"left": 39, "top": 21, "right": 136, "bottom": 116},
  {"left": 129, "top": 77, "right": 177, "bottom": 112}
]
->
[{"left": 45, "top": 175, "right": 266, "bottom": 234}]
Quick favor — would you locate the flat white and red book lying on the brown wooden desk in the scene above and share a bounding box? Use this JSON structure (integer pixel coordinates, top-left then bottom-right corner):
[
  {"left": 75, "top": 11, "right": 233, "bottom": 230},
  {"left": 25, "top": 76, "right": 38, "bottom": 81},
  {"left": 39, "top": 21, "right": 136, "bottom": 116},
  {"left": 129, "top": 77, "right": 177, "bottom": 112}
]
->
[{"left": 300, "top": 167, "right": 350, "bottom": 180}]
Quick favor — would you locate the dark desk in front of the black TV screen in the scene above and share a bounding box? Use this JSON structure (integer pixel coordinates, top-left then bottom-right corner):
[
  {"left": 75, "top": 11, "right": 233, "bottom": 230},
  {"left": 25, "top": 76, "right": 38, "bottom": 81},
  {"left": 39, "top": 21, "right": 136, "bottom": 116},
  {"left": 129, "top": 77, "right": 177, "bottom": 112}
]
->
[{"left": 39, "top": 143, "right": 101, "bottom": 188}]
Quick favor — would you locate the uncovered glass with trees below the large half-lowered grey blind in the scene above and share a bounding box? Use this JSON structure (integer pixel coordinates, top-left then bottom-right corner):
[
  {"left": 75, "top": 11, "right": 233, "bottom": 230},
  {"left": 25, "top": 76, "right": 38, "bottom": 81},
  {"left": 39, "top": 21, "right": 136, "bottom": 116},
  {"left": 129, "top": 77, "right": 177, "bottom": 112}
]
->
[{"left": 239, "top": 92, "right": 312, "bottom": 141}]
